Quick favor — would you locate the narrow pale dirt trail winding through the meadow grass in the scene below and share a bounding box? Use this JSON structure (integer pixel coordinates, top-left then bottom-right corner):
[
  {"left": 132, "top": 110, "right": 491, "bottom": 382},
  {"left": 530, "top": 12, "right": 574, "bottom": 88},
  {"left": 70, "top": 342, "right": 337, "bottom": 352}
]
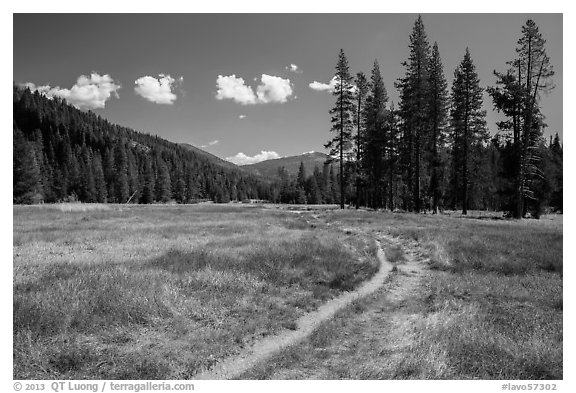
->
[{"left": 193, "top": 237, "right": 393, "bottom": 380}]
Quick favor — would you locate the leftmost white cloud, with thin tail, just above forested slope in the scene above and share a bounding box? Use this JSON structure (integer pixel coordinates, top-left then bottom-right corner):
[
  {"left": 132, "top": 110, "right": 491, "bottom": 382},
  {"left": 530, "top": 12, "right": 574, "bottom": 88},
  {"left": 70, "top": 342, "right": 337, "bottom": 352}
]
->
[{"left": 20, "top": 72, "right": 121, "bottom": 109}]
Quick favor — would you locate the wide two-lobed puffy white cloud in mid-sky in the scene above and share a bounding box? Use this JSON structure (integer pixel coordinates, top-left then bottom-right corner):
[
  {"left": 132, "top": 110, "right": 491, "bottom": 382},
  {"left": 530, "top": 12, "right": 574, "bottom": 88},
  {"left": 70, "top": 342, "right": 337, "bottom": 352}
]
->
[{"left": 216, "top": 74, "right": 293, "bottom": 105}]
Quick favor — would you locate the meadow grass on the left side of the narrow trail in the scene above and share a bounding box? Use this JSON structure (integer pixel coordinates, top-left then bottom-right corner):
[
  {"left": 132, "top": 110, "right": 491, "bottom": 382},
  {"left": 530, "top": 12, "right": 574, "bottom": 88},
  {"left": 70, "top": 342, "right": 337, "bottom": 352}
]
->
[{"left": 13, "top": 205, "right": 377, "bottom": 379}]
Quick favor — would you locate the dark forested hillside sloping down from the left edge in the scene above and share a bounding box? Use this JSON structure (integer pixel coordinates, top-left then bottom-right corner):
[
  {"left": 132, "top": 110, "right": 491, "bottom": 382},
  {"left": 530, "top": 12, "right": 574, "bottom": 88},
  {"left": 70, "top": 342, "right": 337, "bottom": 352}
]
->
[{"left": 13, "top": 86, "right": 269, "bottom": 203}]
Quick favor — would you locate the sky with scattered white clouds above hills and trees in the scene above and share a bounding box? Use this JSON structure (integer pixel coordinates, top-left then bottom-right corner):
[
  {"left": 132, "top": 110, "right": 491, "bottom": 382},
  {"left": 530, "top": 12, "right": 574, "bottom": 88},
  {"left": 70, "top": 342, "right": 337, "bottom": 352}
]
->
[{"left": 13, "top": 14, "right": 563, "bottom": 164}]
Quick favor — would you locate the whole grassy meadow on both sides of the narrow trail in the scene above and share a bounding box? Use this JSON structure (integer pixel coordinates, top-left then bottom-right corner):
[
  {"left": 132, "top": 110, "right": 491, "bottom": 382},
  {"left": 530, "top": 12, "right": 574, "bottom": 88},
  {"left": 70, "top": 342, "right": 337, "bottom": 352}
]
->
[{"left": 13, "top": 204, "right": 563, "bottom": 379}]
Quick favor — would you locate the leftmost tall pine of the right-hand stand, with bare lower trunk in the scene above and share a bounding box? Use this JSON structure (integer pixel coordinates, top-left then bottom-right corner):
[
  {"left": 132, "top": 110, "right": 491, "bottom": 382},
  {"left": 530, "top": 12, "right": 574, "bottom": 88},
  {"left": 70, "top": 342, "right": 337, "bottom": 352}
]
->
[{"left": 324, "top": 49, "right": 354, "bottom": 209}]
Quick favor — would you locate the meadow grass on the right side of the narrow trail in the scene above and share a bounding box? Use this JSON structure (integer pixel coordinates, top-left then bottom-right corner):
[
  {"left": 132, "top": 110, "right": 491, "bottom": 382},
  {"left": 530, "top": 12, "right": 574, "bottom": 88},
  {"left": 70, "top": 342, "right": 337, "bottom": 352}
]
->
[{"left": 242, "top": 211, "right": 563, "bottom": 379}]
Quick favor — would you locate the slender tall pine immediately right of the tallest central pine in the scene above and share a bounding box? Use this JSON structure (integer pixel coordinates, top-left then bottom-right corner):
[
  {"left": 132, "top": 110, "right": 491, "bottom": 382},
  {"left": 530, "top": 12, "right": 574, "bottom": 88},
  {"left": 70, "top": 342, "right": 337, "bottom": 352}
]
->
[{"left": 426, "top": 42, "right": 449, "bottom": 213}]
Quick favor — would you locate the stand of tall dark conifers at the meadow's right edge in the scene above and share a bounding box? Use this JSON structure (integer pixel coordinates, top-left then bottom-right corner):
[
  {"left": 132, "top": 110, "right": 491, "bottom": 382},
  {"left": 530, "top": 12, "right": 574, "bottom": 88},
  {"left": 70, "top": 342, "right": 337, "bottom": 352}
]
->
[{"left": 326, "top": 16, "right": 562, "bottom": 218}]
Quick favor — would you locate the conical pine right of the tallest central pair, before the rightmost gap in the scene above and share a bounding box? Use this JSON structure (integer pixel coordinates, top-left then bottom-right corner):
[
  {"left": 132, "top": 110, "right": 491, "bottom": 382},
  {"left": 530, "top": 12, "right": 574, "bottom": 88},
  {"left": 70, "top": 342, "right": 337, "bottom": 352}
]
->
[{"left": 450, "top": 48, "right": 489, "bottom": 214}]
